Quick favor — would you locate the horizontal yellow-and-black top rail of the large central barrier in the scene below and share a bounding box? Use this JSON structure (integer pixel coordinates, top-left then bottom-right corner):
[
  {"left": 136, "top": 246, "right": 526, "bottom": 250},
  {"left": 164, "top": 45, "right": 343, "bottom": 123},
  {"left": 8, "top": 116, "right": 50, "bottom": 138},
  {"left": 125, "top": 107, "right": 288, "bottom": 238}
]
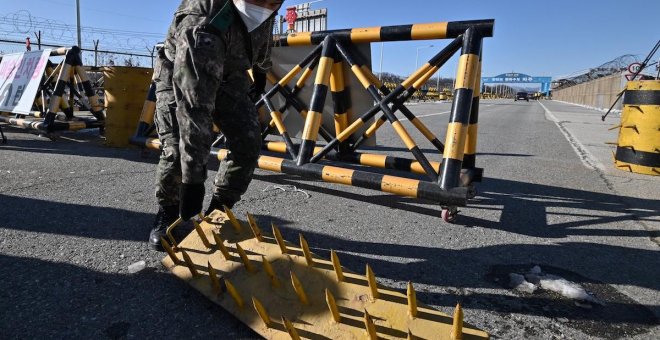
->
[{"left": 274, "top": 19, "right": 495, "bottom": 46}]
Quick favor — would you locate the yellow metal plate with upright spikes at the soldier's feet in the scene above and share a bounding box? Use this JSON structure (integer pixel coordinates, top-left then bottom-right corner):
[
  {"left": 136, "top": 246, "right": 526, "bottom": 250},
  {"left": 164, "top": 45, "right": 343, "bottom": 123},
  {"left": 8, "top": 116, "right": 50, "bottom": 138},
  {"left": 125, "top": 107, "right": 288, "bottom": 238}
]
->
[{"left": 161, "top": 209, "right": 489, "bottom": 340}]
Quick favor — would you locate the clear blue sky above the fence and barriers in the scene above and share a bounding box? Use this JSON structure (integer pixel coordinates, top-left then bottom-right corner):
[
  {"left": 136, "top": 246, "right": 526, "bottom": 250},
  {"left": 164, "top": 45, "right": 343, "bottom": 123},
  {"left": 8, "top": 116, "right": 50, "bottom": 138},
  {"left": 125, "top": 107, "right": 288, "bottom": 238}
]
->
[{"left": 0, "top": 0, "right": 660, "bottom": 77}]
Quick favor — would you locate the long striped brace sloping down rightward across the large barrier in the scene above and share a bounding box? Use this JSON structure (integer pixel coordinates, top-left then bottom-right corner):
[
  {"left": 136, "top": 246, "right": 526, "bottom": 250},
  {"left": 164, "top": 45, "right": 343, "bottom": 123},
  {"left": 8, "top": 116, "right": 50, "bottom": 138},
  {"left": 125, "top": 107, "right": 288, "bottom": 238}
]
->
[{"left": 336, "top": 42, "right": 438, "bottom": 182}]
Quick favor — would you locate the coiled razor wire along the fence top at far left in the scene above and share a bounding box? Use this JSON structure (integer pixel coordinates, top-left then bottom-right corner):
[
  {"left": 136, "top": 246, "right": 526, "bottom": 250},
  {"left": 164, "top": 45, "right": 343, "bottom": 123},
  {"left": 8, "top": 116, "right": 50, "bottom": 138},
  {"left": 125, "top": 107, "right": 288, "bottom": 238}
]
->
[{"left": 0, "top": 10, "right": 164, "bottom": 53}]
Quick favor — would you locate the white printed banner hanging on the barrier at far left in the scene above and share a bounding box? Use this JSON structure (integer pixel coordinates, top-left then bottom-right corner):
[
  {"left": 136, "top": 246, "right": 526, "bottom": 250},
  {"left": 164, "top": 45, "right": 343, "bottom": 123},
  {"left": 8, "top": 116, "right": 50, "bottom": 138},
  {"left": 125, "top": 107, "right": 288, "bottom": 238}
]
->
[{"left": 0, "top": 50, "right": 50, "bottom": 113}]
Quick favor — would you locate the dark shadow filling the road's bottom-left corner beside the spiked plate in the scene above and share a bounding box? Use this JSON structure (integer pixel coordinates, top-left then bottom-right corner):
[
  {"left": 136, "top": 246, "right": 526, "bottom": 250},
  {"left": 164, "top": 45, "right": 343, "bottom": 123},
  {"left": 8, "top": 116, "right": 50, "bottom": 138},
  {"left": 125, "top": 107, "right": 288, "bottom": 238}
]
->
[{"left": 0, "top": 255, "right": 257, "bottom": 339}]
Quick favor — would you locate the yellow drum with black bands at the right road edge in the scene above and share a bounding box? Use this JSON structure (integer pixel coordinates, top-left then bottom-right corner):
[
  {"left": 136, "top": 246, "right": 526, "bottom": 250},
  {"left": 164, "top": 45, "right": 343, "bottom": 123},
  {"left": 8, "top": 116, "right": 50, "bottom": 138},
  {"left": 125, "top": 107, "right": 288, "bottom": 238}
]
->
[{"left": 615, "top": 80, "right": 660, "bottom": 176}]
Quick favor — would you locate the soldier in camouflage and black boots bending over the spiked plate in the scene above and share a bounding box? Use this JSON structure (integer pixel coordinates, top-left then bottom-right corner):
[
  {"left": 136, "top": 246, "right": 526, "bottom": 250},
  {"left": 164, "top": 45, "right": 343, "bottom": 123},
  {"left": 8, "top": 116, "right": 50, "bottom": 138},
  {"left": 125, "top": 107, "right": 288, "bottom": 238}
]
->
[{"left": 149, "top": 0, "right": 283, "bottom": 249}]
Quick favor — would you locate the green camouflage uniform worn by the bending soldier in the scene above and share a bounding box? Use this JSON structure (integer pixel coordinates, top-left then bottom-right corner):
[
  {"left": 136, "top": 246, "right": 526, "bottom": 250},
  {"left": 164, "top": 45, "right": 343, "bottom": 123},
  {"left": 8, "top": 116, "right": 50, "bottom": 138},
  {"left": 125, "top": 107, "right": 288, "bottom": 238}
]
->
[{"left": 157, "top": 0, "right": 273, "bottom": 206}]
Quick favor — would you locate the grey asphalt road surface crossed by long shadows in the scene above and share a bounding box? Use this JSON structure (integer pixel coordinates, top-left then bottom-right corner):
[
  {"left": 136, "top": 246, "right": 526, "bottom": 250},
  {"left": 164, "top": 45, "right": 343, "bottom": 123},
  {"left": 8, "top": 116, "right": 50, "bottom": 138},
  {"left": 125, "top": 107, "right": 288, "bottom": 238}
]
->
[{"left": 0, "top": 101, "right": 660, "bottom": 339}]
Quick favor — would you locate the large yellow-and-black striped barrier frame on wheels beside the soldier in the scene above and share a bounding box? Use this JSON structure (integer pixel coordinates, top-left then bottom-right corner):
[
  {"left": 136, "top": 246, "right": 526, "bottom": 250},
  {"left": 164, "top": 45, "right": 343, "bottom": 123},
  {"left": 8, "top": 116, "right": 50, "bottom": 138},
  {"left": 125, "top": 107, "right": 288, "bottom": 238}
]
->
[{"left": 132, "top": 20, "right": 494, "bottom": 222}]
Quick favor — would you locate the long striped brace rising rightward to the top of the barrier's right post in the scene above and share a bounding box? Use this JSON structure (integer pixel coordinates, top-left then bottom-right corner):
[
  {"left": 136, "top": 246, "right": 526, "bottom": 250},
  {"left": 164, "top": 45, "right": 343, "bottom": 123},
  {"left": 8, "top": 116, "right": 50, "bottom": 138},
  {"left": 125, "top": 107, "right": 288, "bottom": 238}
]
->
[{"left": 312, "top": 36, "right": 463, "bottom": 162}]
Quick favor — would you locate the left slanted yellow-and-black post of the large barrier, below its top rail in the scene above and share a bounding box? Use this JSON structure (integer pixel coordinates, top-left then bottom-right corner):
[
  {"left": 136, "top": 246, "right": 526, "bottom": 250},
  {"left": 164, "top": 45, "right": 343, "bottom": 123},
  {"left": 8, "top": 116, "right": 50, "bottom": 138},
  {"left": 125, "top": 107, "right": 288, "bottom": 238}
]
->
[{"left": 297, "top": 36, "right": 337, "bottom": 165}]
